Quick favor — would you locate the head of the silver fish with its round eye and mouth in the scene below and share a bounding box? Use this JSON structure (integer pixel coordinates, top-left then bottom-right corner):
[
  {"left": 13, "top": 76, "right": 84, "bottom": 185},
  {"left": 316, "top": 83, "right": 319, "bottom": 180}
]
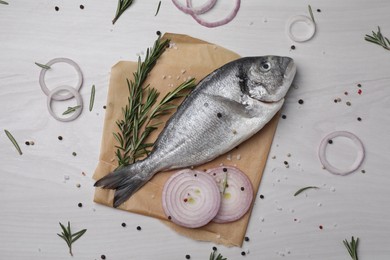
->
[{"left": 245, "top": 56, "right": 296, "bottom": 102}]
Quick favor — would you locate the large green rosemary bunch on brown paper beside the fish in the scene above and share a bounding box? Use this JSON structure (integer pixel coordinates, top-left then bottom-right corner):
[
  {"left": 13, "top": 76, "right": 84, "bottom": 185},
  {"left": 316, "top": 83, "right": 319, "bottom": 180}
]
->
[{"left": 114, "top": 37, "right": 195, "bottom": 168}]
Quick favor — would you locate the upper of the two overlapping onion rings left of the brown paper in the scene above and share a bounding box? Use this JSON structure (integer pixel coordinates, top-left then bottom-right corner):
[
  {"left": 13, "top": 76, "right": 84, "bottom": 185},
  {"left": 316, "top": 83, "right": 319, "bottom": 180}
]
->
[{"left": 39, "top": 58, "right": 83, "bottom": 101}]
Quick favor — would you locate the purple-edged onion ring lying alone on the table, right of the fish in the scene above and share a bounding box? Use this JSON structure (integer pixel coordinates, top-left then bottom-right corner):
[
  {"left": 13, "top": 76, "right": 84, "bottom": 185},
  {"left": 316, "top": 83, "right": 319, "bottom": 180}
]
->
[{"left": 318, "top": 131, "right": 365, "bottom": 175}]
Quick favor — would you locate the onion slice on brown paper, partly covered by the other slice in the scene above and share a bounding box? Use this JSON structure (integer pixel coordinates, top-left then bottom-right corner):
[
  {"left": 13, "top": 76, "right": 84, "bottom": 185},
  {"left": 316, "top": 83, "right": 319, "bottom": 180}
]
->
[{"left": 207, "top": 166, "right": 253, "bottom": 223}]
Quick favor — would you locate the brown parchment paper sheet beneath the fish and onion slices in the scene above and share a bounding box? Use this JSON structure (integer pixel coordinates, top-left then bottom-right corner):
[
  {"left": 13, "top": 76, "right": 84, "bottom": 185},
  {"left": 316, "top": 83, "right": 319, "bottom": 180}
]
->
[{"left": 93, "top": 34, "right": 278, "bottom": 246}]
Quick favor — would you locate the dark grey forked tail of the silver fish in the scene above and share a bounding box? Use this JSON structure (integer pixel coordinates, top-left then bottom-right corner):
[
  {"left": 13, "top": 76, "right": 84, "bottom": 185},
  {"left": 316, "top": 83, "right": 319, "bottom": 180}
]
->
[{"left": 94, "top": 163, "right": 154, "bottom": 208}]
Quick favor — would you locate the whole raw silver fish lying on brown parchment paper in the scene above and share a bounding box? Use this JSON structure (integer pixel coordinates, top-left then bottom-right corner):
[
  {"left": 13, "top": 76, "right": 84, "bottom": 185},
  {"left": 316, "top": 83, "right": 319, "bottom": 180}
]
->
[{"left": 95, "top": 56, "right": 296, "bottom": 207}]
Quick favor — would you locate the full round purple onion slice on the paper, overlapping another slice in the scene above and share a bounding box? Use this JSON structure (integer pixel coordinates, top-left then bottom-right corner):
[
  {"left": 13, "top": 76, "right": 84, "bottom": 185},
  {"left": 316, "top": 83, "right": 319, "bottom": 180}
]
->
[{"left": 162, "top": 169, "right": 221, "bottom": 228}]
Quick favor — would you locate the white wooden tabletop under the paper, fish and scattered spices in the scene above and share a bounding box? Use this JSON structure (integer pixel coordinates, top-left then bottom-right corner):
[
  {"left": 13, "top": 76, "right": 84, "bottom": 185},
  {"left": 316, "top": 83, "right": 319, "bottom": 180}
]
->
[{"left": 0, "top": 0, "right": 390, "bottom": 260}]
